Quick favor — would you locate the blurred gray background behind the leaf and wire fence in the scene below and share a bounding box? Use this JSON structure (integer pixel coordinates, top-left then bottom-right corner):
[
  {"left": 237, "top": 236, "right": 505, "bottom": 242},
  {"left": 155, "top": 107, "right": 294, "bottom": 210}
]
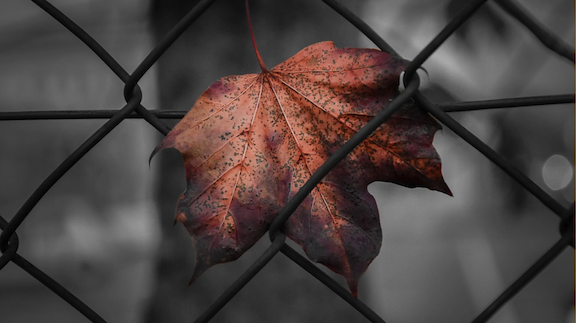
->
[{"left": 0, "top": 0, "right": 575, "bottom": 323}]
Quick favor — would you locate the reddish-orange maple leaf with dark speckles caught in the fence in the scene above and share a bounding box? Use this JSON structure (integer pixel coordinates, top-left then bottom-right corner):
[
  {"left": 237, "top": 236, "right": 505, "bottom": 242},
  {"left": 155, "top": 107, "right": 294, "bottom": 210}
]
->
[{"left": 153, "top": 1, "right": 450, "bottom": 295}]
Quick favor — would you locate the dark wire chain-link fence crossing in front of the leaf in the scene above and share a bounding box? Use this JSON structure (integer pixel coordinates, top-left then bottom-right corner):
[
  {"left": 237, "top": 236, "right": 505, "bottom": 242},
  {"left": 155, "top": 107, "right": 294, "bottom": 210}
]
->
[{"left": 0, "top": 0, "right": 574, "bottom": 323}]
